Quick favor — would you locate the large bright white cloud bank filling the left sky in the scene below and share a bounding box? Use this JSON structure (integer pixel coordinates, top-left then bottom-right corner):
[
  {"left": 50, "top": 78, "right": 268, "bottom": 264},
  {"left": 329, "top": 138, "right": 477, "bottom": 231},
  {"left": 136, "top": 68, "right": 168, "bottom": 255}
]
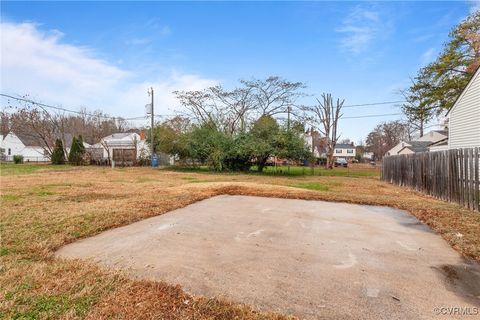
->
[{"left": 0, "top": 22, "right": 216, "bottom": 117}]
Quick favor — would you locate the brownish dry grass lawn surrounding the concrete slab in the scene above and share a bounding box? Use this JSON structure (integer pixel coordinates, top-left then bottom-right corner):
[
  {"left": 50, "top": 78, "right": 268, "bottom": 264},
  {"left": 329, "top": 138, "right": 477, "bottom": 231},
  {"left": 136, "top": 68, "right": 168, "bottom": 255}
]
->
[{"left": 0, "top": 164, "right": 480, "bottom": 319}]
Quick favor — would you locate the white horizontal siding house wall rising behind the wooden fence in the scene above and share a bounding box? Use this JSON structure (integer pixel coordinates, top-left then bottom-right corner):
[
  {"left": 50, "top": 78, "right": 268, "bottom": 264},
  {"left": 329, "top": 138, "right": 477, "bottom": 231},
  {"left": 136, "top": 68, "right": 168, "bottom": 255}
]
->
[{"left": 447, "top": 68, "right": 480, "bottom": 149}]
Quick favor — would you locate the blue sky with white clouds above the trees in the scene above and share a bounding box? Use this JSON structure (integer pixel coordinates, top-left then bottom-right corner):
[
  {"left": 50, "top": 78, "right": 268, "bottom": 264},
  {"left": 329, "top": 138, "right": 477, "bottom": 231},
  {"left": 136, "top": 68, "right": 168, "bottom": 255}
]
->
[{"left": 1, "top": 1, "right": 479, "bottom": 141}]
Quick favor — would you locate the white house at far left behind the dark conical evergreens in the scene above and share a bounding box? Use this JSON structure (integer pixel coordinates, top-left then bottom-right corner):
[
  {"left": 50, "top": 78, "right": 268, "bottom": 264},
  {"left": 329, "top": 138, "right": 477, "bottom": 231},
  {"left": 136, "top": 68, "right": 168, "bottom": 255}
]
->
[{"left": 0, "top": 132, "right": 50, "bottom": 162}]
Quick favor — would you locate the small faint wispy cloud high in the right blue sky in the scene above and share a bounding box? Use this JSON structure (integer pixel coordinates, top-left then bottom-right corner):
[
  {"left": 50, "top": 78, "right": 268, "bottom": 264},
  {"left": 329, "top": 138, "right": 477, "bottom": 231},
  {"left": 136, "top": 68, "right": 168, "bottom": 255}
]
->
[{"left": 336, "top": 5, "right": 391, "bottom": 54}]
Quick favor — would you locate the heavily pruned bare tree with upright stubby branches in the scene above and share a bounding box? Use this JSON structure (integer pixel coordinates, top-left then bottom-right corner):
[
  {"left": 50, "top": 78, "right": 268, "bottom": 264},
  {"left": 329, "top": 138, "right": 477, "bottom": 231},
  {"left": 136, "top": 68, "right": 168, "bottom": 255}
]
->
[{"left": 307, "top": 93, "right": 345, "bottom": 169}]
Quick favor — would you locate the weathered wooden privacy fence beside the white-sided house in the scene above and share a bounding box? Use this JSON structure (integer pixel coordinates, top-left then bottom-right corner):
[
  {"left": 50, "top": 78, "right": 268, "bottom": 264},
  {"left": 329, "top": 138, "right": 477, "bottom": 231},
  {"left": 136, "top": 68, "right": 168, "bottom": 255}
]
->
[{"left": 381, "top": 148, "right": 480, "bottom": 211}]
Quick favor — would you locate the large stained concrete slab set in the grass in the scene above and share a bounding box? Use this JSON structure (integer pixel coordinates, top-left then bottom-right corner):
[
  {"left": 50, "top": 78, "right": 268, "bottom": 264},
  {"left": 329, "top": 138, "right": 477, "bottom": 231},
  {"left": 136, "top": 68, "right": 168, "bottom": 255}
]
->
[{"left": 57, "top": 196, "right": 480, "bottom": 319}]
